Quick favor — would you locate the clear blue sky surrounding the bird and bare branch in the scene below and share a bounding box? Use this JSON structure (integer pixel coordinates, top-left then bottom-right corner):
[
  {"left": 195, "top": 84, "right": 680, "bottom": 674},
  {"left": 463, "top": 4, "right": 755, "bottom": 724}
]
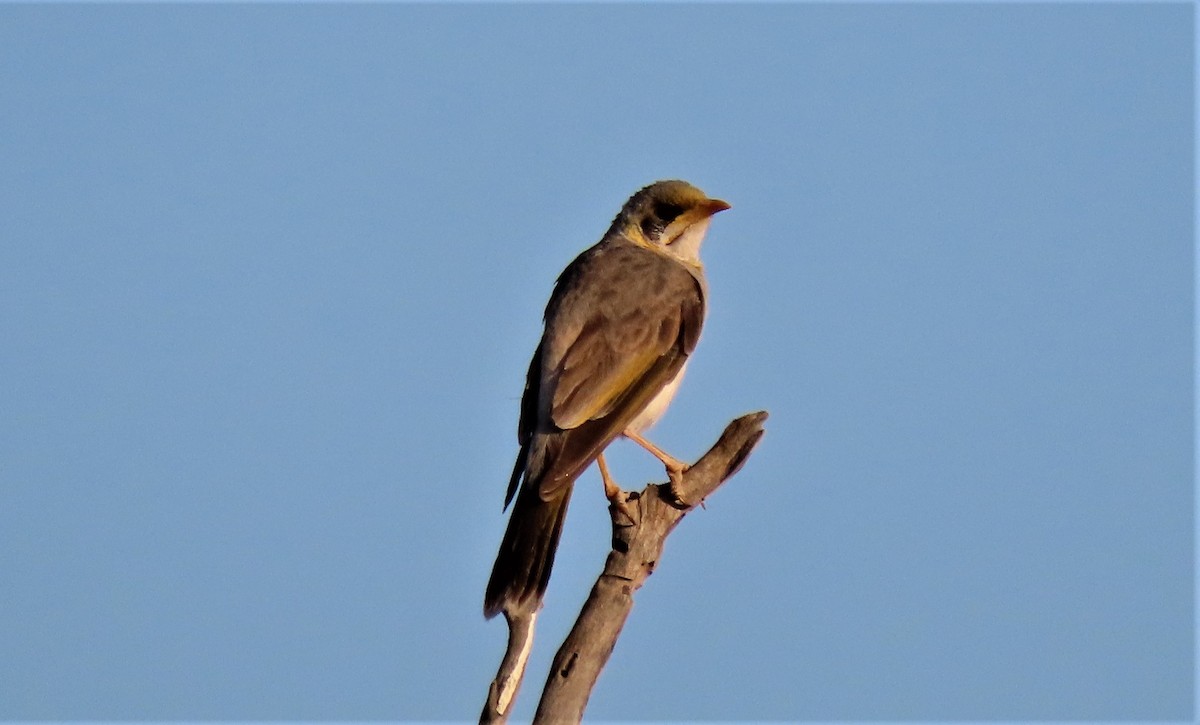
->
[{"left": 0, "top": 4, "right": 1194, "bottom": 720}]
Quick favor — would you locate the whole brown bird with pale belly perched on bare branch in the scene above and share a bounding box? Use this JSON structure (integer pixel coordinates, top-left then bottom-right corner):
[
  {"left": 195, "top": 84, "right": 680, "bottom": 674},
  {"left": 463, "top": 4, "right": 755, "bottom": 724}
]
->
[{"left": 484, "top": 180, "right": 730, "bottom": 618}]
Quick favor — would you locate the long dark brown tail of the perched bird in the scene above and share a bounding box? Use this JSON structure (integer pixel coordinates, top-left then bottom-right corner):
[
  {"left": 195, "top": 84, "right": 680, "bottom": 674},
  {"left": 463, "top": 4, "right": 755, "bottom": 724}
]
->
[{"left": 484, "top": 481, "right": 574, "bottom": 618}]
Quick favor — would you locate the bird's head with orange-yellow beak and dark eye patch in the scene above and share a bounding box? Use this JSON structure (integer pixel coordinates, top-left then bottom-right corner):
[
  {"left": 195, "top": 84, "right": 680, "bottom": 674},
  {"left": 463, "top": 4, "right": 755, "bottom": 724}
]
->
[{"left": 608, "top": 181, "right": 730, "bottom": 262}]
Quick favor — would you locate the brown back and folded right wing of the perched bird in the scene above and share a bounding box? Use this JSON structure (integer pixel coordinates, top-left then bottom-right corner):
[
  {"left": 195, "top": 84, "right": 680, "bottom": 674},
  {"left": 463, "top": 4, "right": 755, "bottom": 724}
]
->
[{"left": 530, "top": 242, "right": 704, "bottom": 499}]
